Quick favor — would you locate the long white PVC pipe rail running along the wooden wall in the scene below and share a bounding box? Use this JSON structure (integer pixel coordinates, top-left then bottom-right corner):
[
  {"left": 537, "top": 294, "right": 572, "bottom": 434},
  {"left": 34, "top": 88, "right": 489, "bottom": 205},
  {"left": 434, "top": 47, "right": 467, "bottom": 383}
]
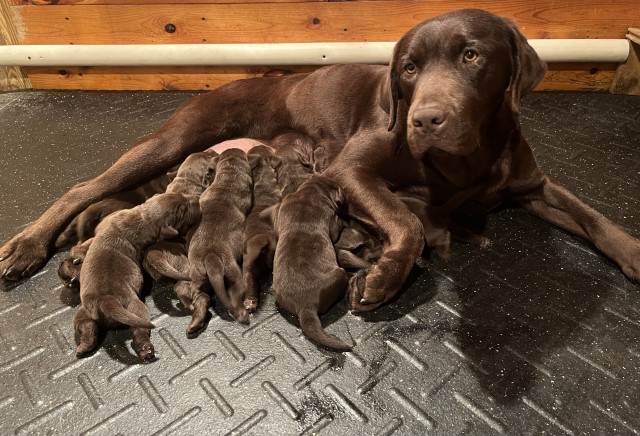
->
[{"left": 0, "top": 39, "right": 629, "bottom": 67}]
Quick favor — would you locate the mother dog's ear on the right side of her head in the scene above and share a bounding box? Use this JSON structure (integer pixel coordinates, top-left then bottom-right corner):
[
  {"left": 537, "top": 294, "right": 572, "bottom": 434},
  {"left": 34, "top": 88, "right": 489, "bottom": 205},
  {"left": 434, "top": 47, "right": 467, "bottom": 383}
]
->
[{"left": 505, "top": 19, "right": 547, "bottom": 114}]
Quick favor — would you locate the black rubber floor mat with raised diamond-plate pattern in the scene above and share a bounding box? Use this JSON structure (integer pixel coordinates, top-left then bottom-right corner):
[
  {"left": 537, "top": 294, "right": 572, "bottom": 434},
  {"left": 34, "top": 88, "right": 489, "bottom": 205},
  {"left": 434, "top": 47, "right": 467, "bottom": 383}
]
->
[{"left": 0, "top": 92, "right": 640, "bottom": 435}]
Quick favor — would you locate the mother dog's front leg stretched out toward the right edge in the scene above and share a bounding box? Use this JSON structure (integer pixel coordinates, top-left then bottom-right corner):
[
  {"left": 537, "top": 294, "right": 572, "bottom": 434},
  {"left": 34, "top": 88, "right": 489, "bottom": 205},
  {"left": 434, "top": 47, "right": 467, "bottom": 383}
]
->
[{"left": 515, "top": 175, "right": 640, "bottom": 282}]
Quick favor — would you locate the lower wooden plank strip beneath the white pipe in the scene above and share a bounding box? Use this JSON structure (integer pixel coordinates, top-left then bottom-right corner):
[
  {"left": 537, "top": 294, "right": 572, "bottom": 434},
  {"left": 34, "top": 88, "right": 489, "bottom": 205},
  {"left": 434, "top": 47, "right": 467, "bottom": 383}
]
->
[{"left": 28, "top": 63, "right": 616, "bottom": 91}]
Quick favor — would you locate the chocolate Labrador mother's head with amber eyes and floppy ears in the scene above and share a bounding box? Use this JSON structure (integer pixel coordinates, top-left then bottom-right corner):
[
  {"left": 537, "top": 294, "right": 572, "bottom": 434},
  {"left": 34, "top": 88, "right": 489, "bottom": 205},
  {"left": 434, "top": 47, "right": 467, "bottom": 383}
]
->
[{"left": 381, "top": 9, "right": 546, "bottom": 158}]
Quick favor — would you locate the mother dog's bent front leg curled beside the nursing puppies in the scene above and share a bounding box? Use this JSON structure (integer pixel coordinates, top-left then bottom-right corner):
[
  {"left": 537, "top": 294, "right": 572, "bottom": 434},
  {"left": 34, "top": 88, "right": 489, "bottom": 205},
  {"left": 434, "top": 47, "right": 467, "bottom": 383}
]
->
[{"left": 336, "top": 168, "right": 424, "bottom": 312}]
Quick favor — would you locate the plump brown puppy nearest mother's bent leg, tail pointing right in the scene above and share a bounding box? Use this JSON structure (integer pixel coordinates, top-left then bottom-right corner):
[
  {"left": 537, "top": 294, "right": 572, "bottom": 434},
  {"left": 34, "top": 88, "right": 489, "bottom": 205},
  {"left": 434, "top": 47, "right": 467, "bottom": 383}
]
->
[{"left": 273, "top": 175, "right": 351, "bottom": 351}]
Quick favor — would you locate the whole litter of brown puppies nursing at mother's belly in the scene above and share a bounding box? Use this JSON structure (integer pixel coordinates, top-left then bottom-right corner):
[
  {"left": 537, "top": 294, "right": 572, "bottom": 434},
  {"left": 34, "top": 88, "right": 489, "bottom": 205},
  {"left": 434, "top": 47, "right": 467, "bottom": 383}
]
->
[{"left": 58, "top": 133, "right": 404, "bottom": 361}]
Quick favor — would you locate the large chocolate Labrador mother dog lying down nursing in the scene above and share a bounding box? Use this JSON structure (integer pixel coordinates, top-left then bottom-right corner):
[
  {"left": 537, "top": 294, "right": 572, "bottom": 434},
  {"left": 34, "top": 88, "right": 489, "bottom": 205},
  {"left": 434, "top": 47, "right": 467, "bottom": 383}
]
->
[{"left": 0, "top": 9, "right": 640, "bottom": 311}]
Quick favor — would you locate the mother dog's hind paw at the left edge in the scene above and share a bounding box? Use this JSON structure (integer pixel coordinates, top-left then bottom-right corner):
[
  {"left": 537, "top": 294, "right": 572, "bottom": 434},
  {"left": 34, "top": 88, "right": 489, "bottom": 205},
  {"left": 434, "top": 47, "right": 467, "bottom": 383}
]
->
[{"left": 0, "top": 233, "right": 49, "bottom": 281}]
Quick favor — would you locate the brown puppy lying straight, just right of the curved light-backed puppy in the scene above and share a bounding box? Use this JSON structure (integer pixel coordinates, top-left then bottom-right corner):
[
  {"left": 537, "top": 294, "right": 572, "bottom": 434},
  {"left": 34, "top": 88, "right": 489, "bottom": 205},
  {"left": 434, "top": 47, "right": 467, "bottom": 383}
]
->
[{"left": 187, "top": 149, "right": 252, "bottom": 328}]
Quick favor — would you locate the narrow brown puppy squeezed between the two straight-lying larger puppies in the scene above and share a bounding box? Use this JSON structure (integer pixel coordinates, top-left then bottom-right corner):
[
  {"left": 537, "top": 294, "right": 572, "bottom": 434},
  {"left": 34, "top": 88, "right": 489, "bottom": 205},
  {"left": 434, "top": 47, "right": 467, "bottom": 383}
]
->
[{"left": 242, "top": 146, "right": 282, "bottom": 313}]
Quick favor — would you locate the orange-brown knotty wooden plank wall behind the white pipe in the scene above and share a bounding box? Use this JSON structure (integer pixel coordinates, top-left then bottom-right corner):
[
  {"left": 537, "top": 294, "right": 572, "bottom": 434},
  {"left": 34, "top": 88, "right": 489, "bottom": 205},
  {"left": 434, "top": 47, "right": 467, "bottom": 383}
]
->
[{"left": 4, "top": 0, "right": 640, "bottom": 90}]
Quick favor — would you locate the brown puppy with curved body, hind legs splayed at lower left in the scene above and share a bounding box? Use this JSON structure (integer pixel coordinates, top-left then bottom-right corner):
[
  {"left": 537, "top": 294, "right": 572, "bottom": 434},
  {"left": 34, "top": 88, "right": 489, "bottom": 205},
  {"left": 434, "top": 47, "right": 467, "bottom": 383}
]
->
[{"left": 73, "top": 194, "right": 200, "bottom": 360}]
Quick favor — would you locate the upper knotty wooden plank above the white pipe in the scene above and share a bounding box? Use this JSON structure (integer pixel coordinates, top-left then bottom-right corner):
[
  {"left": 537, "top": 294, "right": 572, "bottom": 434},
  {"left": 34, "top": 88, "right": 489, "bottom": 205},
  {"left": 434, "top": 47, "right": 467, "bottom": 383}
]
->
[{"left": 12, "top": 0, "right": 640, "bottom": 44}]
